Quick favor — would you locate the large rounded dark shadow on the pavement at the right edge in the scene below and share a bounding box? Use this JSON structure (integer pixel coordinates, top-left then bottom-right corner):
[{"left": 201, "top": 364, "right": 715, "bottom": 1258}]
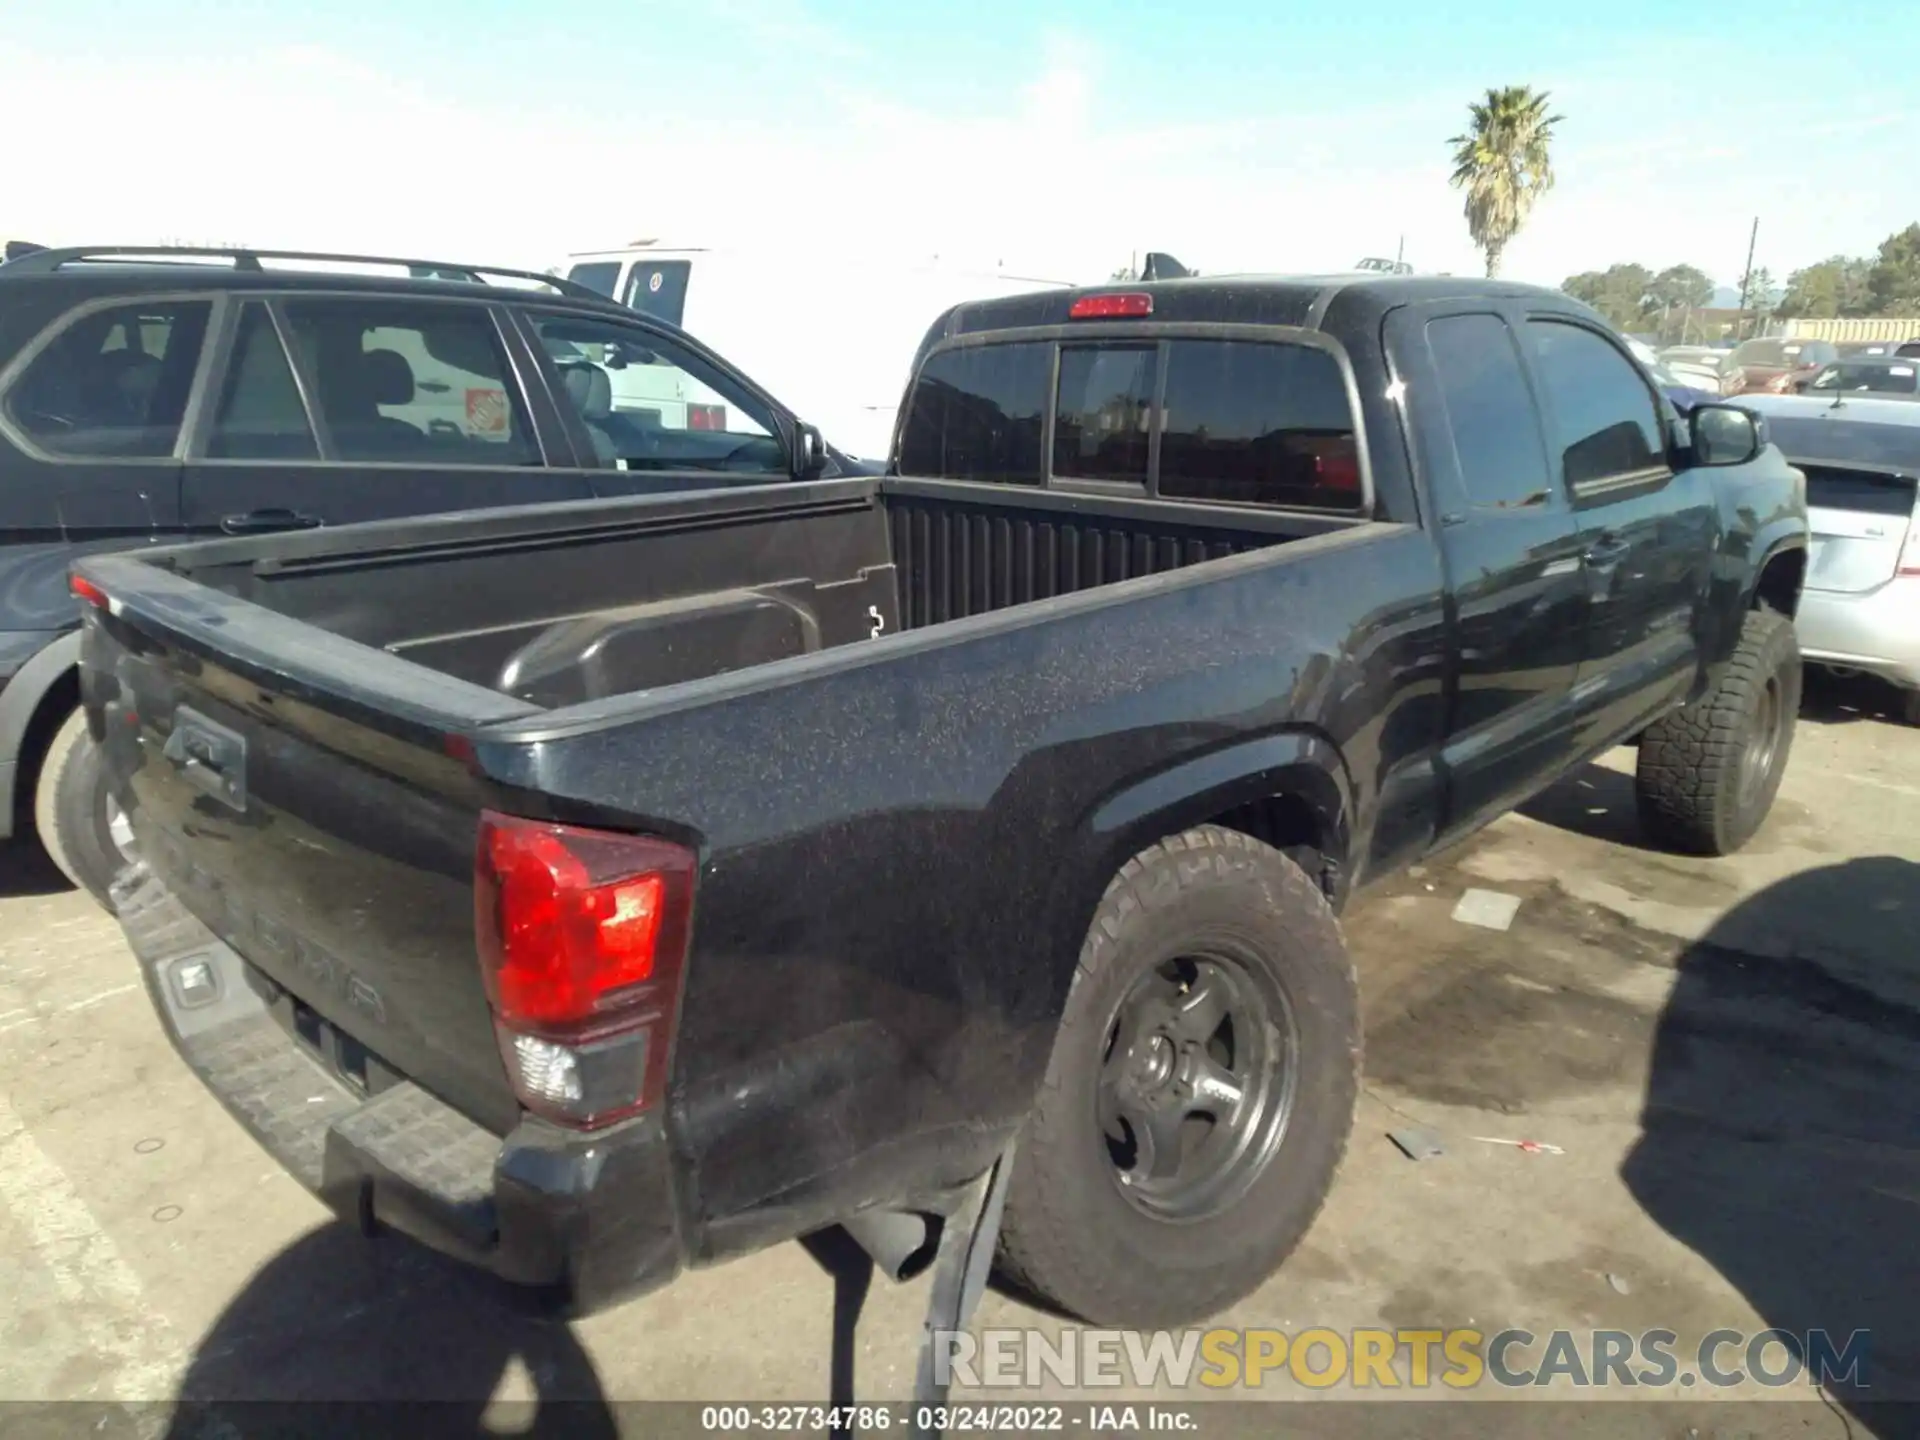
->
[{"left": 1620, "top": 856, "right": 1920, "bottom": 1438}]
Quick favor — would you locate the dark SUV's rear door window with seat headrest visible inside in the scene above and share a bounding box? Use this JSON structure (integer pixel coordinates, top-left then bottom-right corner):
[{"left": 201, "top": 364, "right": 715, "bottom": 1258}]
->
[{"left": 284, "top": 300, "right": 540, "bottom": 465}]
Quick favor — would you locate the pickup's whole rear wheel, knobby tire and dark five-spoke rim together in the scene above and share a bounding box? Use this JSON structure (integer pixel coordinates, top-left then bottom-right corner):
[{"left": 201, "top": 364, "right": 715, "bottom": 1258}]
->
[{"left": 1000, "top": 826, "right": 1361, "bottom": 1329}]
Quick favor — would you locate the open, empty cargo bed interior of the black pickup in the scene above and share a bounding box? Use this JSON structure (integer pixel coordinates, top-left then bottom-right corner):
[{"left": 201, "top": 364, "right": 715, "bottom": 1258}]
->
[{"left": 142, "top": 478, "right": 1352, "bottom": 708}]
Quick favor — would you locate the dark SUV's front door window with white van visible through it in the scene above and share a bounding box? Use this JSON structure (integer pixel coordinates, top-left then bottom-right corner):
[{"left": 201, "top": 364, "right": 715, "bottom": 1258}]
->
[{"left": 534, "top": 315, "right": 787, "bottom": 474}]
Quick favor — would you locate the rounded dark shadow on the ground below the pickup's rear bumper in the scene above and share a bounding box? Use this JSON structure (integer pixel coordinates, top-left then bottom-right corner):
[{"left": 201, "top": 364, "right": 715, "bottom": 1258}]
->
[{"left": 169, "top": 1225, "right": 618, "bottom": 1440}]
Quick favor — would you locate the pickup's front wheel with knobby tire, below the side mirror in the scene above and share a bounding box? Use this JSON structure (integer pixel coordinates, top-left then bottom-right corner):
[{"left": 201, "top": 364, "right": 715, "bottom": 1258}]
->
[{"left": 1634, "top": 611, "right": 1801, "bottom": 854}]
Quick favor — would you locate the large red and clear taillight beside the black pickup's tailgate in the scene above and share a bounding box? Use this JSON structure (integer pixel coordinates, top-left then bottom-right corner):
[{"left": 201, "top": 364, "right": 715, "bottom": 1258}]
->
[{"left": 474, "top": 810, "right": 695, "bottom": 1127}]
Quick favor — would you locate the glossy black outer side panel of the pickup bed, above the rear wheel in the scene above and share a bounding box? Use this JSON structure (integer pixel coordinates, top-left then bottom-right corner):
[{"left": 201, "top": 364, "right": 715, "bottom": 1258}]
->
[{"left": 478, "top": 524, "right": 1444, "bottom": 1252}]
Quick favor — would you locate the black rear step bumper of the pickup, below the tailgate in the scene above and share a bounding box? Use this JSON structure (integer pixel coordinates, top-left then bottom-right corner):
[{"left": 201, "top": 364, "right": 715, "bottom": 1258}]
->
[{"left": 113, "top": 866, "right": 685, "bottom": 1313}]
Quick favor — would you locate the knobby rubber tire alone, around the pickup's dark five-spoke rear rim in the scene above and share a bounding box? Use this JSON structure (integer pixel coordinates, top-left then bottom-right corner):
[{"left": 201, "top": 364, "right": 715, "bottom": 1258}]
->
[{"left": 998, "top": 826, "right": 1361, "bottom": 1329}]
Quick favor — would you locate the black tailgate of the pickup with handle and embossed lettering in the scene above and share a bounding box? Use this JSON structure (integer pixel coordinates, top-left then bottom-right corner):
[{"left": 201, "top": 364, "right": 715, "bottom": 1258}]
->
[{"left": 77, "top": 557, "right": 532, "bottom": 1135}]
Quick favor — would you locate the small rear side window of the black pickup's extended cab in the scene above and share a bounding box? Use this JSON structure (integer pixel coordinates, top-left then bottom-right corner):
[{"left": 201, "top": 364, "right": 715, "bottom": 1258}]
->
[{"left": 1427, "top": 315, "right": 1551, "bottom": 509}]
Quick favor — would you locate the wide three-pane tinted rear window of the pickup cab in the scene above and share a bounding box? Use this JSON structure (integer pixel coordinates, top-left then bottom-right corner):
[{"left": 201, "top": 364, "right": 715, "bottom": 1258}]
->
[{"left": 899, "top": 332, "right": 1365, "bottom": 515}]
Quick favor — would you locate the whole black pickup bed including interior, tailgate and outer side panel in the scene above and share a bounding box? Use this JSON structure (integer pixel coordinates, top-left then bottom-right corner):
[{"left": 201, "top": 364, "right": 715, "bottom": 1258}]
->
[{"left": 75, "top": 478, "right": 1405, "bottom": 1288}]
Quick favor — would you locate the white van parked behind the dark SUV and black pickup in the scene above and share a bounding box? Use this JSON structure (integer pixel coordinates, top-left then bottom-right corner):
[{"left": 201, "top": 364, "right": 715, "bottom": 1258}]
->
[{"left": 559, "top": 242, "right": 1071, "bottom": 459}]
